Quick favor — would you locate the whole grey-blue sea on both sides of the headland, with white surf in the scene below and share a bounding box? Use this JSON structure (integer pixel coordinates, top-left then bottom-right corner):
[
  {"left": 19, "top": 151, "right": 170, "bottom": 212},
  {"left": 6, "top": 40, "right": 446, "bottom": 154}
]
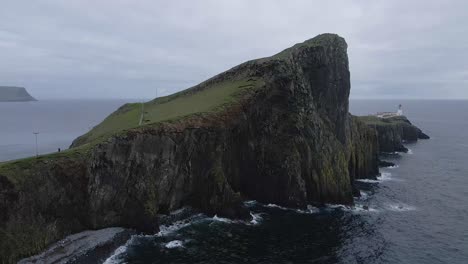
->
[{"left": 0, "top": 100, "right": 468, "bottom": 263}]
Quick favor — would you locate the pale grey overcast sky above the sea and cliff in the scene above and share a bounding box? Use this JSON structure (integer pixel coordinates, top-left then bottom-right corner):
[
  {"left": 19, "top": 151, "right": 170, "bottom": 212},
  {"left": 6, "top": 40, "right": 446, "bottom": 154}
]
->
[{"left": 0, "top": 0, "right": 468, "bottom": 99}]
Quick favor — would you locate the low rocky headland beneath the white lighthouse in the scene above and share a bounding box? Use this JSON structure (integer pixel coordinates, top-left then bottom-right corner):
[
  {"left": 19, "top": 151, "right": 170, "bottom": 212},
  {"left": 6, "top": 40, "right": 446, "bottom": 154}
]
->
[{"left": 359, "top": 116, "right": 429, "bottom": 153}]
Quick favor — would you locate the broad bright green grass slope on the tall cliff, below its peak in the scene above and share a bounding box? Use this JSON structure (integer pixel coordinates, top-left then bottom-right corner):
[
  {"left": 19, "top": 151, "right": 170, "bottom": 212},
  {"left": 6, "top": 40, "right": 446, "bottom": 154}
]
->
[{"left": 73, "top": 78, "right": 263, "bottom": 145}]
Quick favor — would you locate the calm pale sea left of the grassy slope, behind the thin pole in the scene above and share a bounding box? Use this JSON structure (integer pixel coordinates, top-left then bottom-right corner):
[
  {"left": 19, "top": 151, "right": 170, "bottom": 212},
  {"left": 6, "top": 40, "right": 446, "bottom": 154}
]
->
[{"left": 0, "top": 99, "right": 136, "bottom": 162}]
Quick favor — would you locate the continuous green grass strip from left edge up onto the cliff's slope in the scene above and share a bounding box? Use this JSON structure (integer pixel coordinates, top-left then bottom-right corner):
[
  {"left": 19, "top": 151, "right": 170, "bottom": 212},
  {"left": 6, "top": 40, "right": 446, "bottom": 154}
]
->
[{"left": 0, "top": 78, "right": 264, "bottom": 171}]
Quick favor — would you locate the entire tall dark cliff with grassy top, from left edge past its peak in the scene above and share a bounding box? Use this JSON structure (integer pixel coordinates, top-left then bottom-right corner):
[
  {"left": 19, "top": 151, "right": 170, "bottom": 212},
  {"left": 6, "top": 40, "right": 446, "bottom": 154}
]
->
[{"left": 0, "top": 34, "right": 424, "bottom": 262}]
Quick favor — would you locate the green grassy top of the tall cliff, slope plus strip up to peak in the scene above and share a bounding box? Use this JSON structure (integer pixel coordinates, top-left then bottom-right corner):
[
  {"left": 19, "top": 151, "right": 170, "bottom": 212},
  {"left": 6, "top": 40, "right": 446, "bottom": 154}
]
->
[{"left": 72, "top": 33, "right": 346, "bottom": 147}]
